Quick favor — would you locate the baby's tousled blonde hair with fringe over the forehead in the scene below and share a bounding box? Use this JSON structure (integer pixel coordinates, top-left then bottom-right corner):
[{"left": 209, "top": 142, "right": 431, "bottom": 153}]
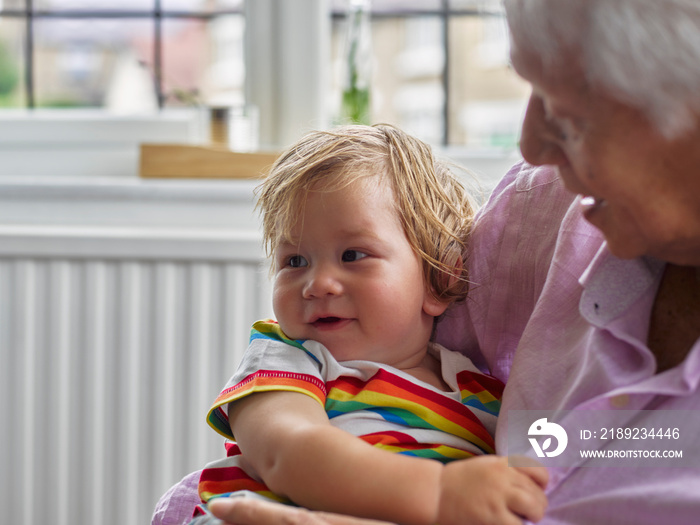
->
[{"left": 256, "top": 124, "right": 474, "bottom": 302}]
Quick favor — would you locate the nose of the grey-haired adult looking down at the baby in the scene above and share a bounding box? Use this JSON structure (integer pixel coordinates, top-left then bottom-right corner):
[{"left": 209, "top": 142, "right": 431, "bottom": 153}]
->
[{"left": 520, "top": 93, "right": 567, "bottom": 166}]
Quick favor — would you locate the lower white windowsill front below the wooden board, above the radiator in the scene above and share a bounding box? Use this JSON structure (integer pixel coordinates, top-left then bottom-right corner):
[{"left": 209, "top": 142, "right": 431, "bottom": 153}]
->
[{"left": 0, "top": 176, "right": 258, "bottom": 232}]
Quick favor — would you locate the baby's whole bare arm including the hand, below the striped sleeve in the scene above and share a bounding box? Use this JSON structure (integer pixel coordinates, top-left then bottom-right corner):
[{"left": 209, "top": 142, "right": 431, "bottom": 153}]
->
[{"left": 229, "top": 391, "right": 546, "bottom": 525}]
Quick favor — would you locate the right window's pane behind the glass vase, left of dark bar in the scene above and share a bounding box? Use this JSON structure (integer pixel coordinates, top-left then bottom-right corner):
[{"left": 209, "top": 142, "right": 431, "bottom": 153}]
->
[{"left": 333, "top": 16, "right": 445, "bottom": 144}]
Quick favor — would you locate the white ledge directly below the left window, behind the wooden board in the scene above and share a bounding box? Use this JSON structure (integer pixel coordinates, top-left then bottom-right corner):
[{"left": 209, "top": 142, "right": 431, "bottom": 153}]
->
[{"left": 0, "top": 109, "right": 205, "bottom": 178}]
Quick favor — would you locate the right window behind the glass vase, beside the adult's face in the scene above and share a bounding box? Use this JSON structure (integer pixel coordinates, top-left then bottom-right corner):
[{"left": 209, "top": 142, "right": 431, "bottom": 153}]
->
[{"left": 332, "top": 0, "right": 529, "bottom": 150}]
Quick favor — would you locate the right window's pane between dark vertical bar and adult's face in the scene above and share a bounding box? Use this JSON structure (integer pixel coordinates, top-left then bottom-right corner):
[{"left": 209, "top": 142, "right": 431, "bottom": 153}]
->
[{"left": 449, "top": 16, "right": 530, "bottom": 148}]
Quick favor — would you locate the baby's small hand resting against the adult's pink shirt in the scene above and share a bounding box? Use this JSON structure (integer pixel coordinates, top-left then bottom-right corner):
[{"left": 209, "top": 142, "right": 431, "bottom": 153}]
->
[{"left": 437, "top": 456, "right": 548, "bottom": 525}]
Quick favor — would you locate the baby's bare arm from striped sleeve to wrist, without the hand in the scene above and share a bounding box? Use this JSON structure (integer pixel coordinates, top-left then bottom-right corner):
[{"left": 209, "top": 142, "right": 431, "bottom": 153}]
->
[{"left": 229, "top": 391, "right": 442, "bottom": 525}]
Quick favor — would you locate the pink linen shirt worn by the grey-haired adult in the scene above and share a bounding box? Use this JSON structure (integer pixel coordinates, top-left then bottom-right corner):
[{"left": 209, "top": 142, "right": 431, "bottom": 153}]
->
[{"left": 153, "top": 163, "right": 700, "bottom": 525}]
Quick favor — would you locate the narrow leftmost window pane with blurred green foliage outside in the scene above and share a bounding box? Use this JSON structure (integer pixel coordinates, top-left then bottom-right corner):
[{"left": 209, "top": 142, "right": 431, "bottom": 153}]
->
[{"left": 0, "top": 18, "right": 26, "bottom": 107}]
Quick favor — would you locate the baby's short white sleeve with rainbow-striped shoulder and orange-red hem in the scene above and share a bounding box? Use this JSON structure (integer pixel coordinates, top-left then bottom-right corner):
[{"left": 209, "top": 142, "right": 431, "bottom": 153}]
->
[{"left": 207, "top": 320, "right": 326, "bottom": 439}]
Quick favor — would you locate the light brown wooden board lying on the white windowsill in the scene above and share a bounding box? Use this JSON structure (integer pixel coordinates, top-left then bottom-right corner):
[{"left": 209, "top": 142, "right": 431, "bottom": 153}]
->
[{"left": 139, "top": 144, "right": 278, "bottom": 179}]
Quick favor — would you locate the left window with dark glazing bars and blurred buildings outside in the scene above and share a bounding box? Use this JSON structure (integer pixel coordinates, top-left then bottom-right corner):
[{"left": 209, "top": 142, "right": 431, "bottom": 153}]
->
[{"left": 0, "top": 0, "right": 244, "bottom": 113}]
